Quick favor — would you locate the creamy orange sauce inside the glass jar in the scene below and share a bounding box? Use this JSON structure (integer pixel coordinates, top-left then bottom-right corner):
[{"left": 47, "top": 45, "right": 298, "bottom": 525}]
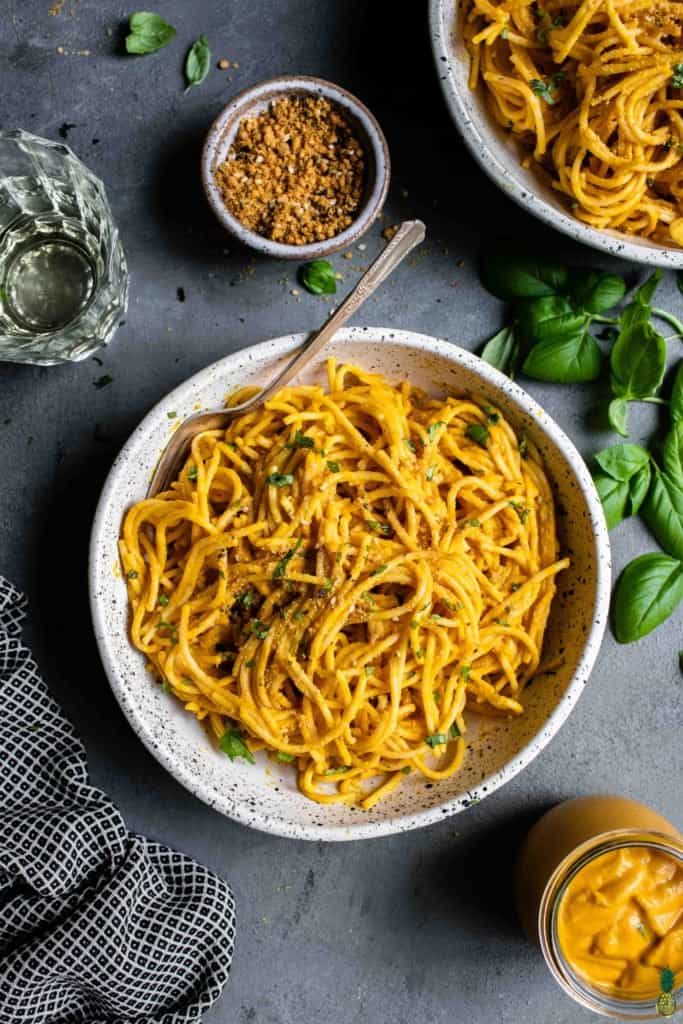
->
[{"left": 557, "top": 846, "right": 683, "bottom": 999}]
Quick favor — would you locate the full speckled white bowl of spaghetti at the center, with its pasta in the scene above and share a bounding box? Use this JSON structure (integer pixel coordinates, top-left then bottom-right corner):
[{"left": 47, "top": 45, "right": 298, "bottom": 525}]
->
[{"left": 90, "top": 328, "right": 610, "bottom": 840}]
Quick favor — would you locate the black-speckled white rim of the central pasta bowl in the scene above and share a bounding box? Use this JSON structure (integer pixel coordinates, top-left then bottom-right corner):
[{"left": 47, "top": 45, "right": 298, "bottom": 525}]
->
[{"left": 88, "top": 327, "right": 611, "bottom": 842}]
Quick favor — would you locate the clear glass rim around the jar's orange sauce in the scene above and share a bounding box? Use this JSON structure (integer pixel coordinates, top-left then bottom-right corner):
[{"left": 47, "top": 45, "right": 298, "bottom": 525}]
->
[{"left": 538, "top": 828, "right": 683, "bottom": 1021}]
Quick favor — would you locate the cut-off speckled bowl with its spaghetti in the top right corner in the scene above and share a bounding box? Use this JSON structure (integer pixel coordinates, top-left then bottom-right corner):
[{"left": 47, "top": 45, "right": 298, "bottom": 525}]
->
[{"left": 430, "top": 0, "right": 683, "bottom": 268}]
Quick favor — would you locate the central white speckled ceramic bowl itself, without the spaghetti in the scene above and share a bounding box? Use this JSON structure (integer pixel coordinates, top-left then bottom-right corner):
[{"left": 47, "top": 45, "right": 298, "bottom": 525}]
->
[{"left": 89, "top": 328, "right": 610, "bottom": 840}]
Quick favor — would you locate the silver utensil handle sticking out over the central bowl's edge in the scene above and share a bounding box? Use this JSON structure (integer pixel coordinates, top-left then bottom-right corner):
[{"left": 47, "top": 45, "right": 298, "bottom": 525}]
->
[{"left": 248, "top": 220, "right": 426, "bottom": 412}]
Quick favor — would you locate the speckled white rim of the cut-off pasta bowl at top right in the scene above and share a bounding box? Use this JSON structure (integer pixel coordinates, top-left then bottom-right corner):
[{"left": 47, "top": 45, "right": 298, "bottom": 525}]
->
[{"left": 429, "top": 0, "right": 683, "bottom": 269}]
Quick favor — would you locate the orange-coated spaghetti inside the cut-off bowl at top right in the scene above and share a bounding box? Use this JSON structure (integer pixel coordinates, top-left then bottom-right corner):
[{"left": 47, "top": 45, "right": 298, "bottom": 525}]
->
[{"left": 461, "top": 0, "right": 683, "bottom": 246}]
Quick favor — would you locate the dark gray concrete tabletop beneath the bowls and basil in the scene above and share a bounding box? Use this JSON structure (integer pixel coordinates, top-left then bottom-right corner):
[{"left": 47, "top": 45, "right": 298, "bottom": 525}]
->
[{"left": 0, "top": 0, "right": 683, "bottom": 1024}]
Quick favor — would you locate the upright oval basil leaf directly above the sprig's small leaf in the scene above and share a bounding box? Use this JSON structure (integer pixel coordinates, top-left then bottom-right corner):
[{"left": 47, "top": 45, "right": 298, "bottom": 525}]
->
[{"left": 609, "top": 323, "right": 667, "bottom": 400}]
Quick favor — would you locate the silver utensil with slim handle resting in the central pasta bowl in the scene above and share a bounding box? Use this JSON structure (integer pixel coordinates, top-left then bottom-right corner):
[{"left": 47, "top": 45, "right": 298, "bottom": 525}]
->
[{"left": 147, "top": 220, "right": 425, "bottom": 498}]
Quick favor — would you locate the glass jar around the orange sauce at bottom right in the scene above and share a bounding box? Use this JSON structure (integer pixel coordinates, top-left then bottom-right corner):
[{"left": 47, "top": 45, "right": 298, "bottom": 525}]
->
[{"left": 515, "top": 797, "right": 683, "bottom": 1021}]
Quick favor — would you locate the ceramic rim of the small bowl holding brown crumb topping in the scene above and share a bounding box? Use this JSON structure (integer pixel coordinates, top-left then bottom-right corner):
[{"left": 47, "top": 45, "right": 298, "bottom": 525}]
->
[{"left": 202, "top": 75, "right": 391, "bottom": 262}]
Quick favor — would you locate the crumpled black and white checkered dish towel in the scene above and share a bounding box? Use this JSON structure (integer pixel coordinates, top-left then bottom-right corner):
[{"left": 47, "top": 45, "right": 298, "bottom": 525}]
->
[{"left": 0, "top": 577, "right": 234, "bottom": 1024}]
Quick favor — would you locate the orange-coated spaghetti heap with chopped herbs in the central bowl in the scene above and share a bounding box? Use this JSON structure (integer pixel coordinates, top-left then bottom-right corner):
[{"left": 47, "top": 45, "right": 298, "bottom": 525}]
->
[{"left": 120, "top": 360, "right": 568, "bottom": 808}]
